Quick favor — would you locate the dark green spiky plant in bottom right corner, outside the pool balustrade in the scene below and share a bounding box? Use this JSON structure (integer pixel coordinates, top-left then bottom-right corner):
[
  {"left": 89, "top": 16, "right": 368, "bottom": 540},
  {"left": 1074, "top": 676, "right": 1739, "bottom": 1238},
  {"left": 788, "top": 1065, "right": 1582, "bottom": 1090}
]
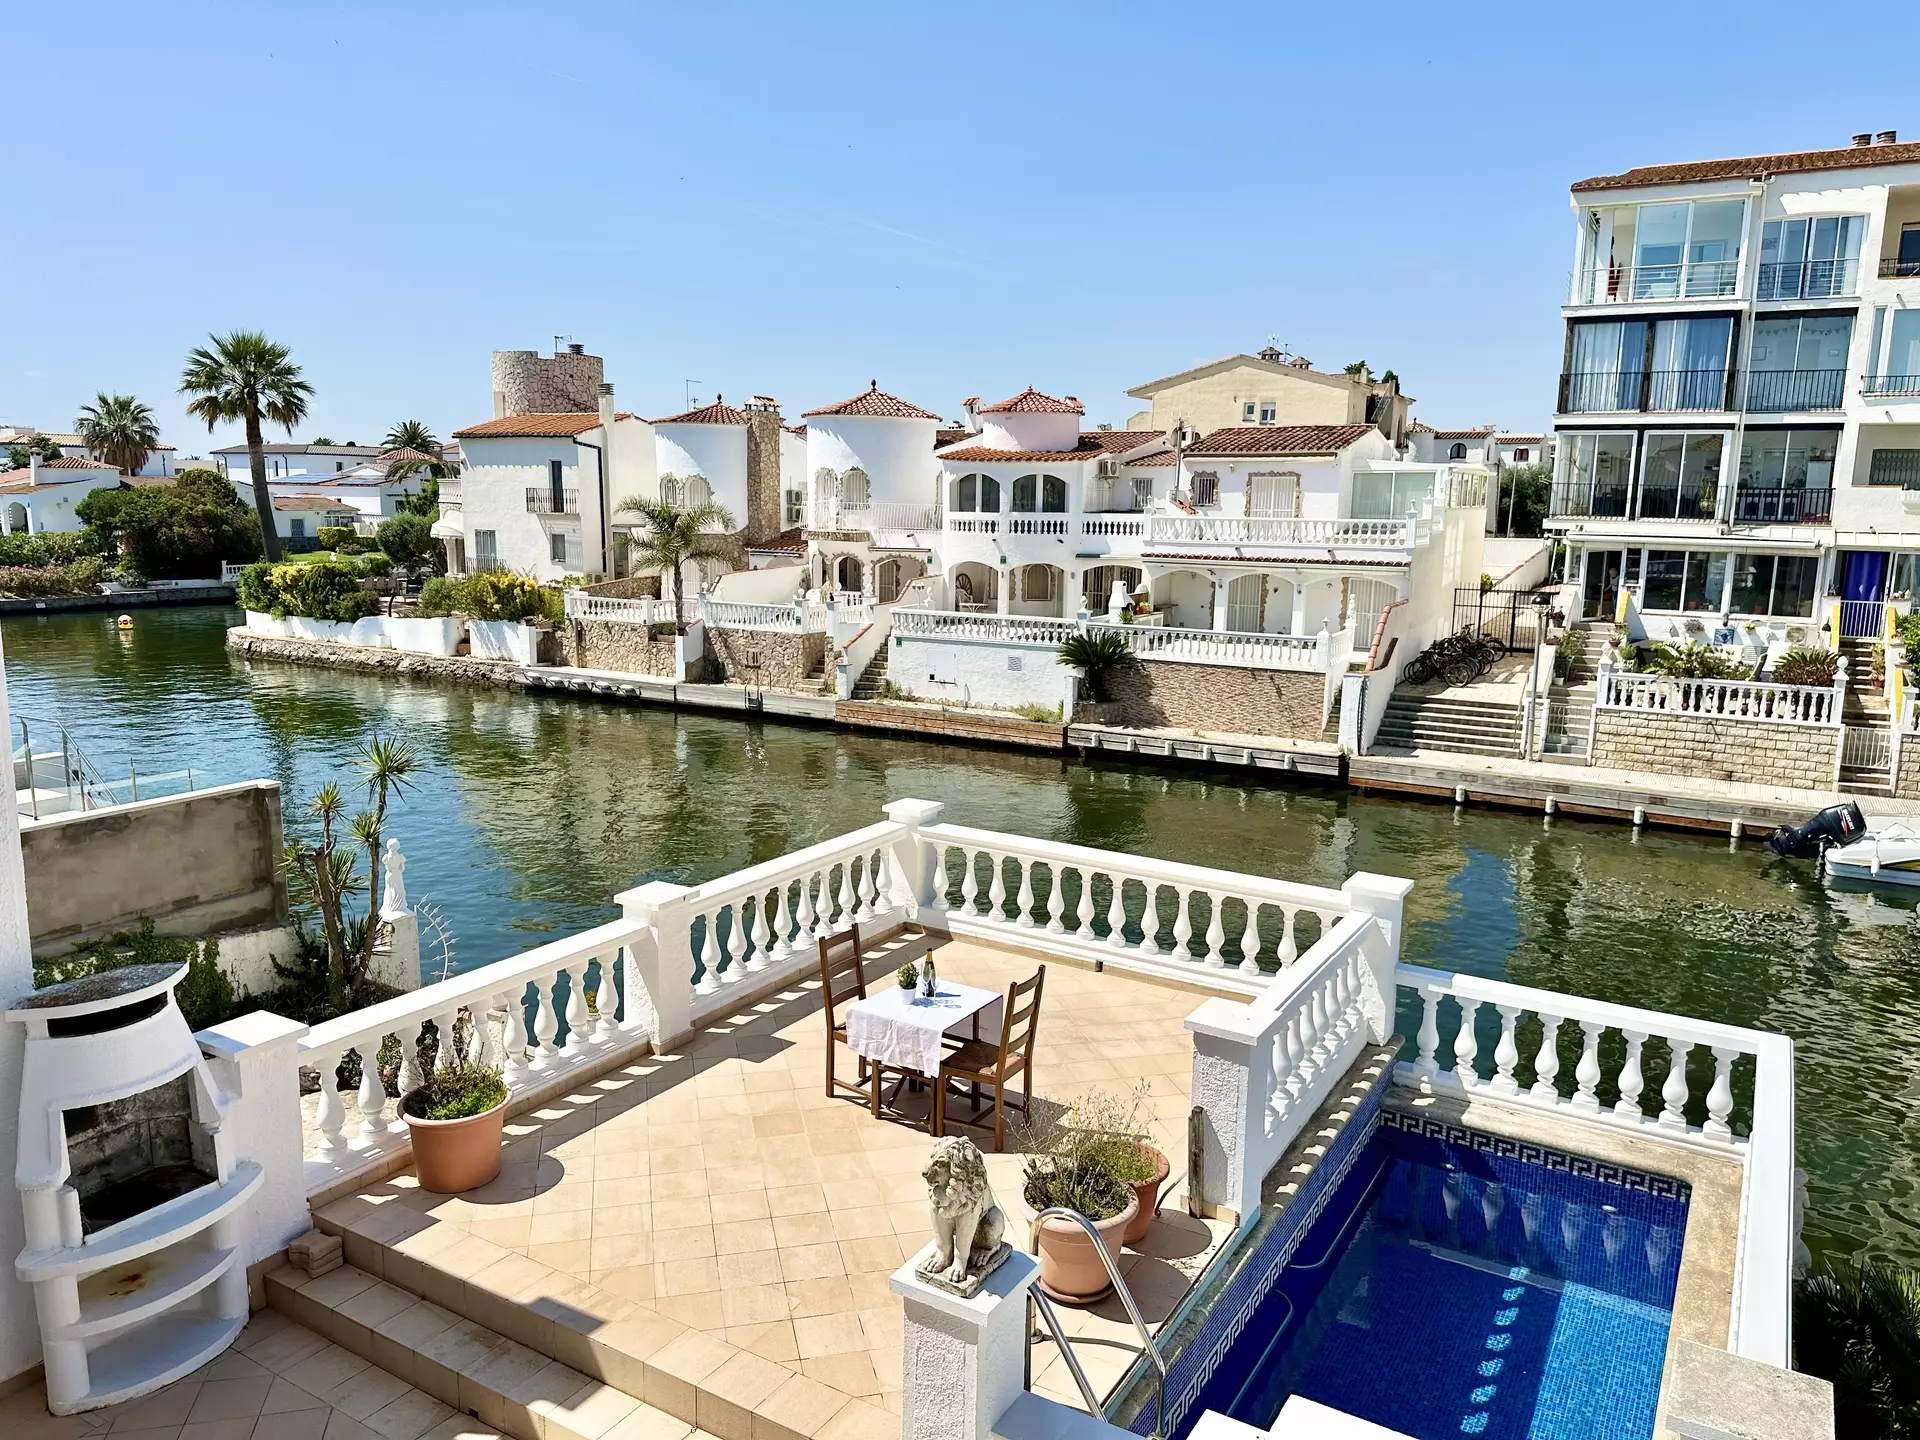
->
[{"left": 1793, "top": 1260, "right": 1920, "bottom": 1440}]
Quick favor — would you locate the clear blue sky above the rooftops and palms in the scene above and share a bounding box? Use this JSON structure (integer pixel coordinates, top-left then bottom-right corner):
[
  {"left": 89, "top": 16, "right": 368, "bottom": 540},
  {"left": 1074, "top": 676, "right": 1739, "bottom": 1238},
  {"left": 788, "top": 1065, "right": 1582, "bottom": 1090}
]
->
[{"left": 11, "top": 0, "right": 1920, "bottom": 451}]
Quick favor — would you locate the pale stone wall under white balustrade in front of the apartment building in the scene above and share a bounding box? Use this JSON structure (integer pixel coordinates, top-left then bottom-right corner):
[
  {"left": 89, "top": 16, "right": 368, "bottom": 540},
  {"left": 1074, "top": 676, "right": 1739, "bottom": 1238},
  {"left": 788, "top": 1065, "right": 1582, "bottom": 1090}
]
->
[{"left": 1594, "top": 710, "right": 1839, "bottom": 791}]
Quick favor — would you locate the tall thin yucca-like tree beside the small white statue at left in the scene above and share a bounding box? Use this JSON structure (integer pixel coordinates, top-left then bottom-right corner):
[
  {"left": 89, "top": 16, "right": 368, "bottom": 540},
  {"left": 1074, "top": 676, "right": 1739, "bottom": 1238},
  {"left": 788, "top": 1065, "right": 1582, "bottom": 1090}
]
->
[{"left": 284, "top": 735, "right": 420, "bottom": 1014}]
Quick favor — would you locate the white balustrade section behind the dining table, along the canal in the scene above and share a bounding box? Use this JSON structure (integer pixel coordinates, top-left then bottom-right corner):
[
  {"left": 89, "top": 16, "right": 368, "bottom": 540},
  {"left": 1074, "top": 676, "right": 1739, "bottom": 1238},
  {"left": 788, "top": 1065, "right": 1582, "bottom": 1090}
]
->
[{"left": 920, "top": 826, "right": 1354, "bottom": 995}]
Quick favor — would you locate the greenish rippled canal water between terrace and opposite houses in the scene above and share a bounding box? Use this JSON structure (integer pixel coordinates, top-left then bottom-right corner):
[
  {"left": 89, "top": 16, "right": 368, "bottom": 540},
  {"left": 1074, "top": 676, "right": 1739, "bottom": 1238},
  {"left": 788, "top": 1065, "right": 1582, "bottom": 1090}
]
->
[{"left": 0, "top": 607, "right": 1920, "bottom": 1265}]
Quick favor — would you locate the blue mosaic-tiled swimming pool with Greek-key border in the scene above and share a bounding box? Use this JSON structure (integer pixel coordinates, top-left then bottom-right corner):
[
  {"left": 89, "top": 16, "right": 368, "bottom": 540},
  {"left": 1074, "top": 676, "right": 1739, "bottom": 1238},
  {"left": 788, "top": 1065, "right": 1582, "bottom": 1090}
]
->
[{"left": 1128, "top": 1110, "right": 1690, "bottom": 1440}]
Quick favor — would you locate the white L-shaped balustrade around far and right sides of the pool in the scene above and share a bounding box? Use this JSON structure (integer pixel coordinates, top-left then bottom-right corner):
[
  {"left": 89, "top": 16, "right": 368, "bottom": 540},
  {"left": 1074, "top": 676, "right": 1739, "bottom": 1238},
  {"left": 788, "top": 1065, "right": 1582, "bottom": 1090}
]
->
[{"left": 1396, "top": 964, "right": 1799, "bottom": 1365}]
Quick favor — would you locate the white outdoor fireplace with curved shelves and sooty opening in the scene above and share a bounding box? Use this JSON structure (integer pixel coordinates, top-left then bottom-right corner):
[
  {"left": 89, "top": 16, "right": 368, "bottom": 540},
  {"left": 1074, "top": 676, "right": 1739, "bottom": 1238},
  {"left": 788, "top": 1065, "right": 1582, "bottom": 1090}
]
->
[{"left": 6, "top": 966, "right": 261, "bottom": 1415}]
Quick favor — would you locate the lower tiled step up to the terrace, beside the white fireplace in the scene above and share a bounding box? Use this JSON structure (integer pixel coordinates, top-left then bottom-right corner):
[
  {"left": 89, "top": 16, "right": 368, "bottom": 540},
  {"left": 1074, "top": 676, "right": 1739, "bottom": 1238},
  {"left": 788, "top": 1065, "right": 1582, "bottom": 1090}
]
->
[{"left": 267, "top": 1265, "right": 695, "bottom": 1440}]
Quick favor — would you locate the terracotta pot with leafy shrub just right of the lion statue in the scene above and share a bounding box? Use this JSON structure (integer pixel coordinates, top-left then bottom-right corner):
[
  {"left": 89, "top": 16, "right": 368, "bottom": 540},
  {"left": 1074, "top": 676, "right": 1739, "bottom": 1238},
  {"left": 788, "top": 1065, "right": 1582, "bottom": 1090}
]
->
[{"left": 1020, "top": 1096, "right": 1140, "bottom": 1306}]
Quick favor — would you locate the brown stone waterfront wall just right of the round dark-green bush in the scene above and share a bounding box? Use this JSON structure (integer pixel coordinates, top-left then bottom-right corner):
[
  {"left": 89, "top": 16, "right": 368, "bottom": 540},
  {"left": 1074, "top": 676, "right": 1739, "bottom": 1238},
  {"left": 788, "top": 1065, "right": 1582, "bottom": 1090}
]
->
[{"left": 1098, "top": 660, "right": 1327, "bottom": 739}]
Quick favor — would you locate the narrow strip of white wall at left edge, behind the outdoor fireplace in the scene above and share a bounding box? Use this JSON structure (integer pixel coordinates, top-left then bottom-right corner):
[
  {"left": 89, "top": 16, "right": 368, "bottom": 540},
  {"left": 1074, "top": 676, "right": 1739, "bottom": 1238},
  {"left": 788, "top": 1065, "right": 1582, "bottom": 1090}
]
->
[{"left": 0, "top": 633, "right": 40, "bottom": 1380}]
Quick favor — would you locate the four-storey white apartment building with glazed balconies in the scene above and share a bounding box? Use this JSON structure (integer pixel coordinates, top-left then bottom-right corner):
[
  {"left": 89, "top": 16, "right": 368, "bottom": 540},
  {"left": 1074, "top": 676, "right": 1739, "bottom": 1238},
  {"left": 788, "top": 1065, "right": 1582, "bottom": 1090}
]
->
[{"left": 1548, "top": 131, "right": 1920, "bottom": 637}]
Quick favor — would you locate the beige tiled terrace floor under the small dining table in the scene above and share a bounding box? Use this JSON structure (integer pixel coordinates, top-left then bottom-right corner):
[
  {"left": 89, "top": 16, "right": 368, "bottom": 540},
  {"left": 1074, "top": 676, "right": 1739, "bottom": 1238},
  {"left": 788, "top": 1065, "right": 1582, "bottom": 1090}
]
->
[{"left": 321, "top": 937, "right": 1223, "bottom": 1440}]
